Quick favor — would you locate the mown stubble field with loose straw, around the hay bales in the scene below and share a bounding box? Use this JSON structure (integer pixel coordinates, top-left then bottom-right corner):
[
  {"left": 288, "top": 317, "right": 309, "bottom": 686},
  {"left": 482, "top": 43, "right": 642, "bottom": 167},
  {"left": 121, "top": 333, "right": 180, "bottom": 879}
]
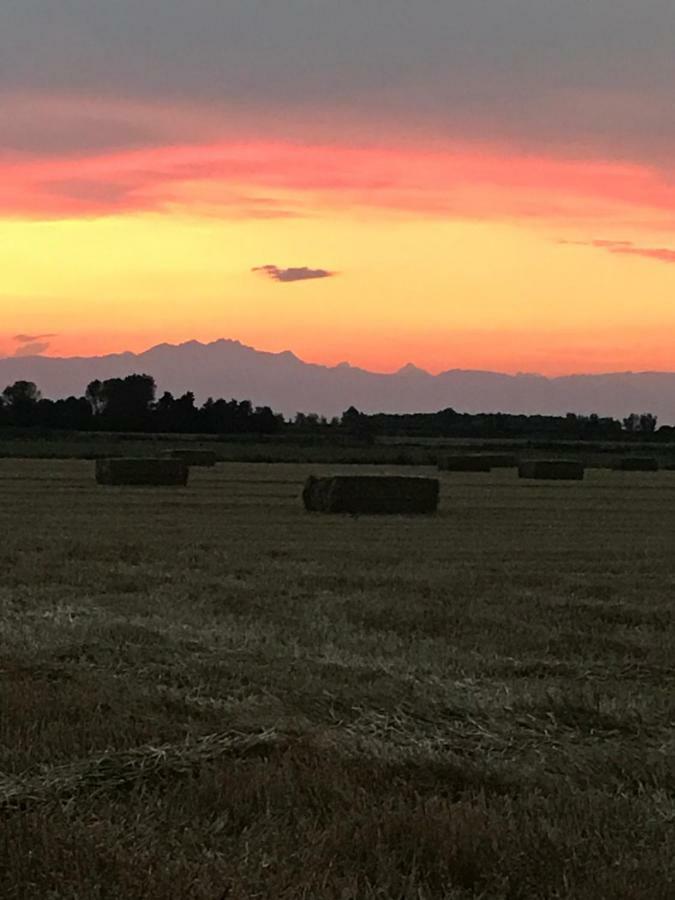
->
[{"left": 0, "top": 459, "right": 675, "bottom": 900}]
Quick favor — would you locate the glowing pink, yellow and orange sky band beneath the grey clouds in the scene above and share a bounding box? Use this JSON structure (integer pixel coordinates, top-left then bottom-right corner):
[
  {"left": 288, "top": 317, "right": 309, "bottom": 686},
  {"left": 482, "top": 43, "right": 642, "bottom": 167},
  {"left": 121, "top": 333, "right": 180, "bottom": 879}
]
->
[{"left": 0, "top": 101, "right": 675, "bottom": 374}]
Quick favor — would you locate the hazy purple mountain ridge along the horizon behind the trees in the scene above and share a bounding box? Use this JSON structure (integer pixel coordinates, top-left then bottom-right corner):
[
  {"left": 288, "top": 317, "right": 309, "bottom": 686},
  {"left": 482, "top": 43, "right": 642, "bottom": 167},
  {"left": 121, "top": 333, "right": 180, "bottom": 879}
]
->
[{"left": 0, "top": 339, "right": 675, "bottom": 425}]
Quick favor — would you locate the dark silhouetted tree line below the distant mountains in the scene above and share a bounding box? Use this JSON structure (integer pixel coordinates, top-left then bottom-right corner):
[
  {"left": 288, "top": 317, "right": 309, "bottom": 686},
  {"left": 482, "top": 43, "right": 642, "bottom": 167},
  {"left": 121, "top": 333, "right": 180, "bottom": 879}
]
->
[{"left": 0, "top": 375, "right": 675, "bottom": 442}]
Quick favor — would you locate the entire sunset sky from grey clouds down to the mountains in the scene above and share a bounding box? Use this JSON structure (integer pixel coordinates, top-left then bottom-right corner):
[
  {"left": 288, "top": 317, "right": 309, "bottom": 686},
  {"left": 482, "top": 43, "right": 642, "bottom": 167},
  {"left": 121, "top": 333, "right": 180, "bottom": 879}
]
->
[{"left": 0, "top": 0, "right": 675, "bottom": 375}]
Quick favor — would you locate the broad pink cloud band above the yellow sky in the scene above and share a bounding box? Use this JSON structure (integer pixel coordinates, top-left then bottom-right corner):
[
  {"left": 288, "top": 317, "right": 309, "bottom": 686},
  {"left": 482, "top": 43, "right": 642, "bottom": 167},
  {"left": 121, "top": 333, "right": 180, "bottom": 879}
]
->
[{"left": 0, "top": 95, "right": 675, "bottom": 228}]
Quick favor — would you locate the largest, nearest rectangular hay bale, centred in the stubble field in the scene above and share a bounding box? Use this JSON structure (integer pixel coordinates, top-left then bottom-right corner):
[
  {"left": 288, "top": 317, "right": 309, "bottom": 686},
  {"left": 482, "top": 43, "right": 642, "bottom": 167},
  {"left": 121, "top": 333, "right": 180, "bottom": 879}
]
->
[{"left": 302, "top": 475, "right": 439, "bottom": 515}]
